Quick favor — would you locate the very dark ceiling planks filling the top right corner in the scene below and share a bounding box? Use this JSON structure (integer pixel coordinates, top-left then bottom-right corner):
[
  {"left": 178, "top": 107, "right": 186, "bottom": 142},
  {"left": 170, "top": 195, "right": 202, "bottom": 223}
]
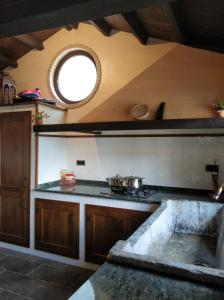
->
[{"left": 170, "top": 0, "right": 224, "bottom": 52}]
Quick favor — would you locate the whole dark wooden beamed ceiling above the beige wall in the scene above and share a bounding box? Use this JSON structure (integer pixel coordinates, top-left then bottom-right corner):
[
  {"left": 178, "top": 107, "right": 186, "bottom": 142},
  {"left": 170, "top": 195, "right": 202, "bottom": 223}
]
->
[{"left": 0, "top": 0, "right": 224, "bottom": 70}]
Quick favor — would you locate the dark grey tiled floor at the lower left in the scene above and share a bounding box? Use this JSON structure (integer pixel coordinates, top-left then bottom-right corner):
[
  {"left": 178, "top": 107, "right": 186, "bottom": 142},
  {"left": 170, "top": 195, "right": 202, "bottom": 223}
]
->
[{"left": 0, "top": 248, "right": 93, "bottom": 300}]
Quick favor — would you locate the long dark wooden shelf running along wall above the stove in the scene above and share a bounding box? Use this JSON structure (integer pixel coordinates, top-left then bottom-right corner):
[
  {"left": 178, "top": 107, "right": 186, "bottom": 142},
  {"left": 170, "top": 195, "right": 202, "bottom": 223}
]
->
[{"left": 33, "top": 118, "right": 224, "bottom": 137}]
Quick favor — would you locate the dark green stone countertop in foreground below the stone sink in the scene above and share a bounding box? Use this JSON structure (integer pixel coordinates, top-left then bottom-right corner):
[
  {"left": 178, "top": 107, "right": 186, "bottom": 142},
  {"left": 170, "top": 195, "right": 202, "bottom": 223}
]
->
[{"left": 69, "top": 262, "right": 224, "bottom": 300}]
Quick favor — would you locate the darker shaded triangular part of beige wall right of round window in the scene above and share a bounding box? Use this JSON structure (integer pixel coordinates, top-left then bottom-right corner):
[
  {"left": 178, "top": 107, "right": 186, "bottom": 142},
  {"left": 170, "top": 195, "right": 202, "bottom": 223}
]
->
[{"left": 82, "top": 45, "right": 224, "bottom": 122}]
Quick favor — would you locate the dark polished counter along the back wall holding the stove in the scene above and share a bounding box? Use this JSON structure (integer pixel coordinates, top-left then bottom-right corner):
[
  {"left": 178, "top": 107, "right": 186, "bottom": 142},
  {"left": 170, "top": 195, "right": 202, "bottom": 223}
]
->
[{"left": 35, "top": 180, "right": 212, "bottom": 203}]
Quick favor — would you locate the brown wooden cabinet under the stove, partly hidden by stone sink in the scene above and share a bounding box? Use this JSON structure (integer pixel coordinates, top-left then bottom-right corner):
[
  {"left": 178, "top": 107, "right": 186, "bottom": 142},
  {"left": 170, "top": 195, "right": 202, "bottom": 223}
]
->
[{"left": 86, "top": 205, "right": 151, "bottom": 264}]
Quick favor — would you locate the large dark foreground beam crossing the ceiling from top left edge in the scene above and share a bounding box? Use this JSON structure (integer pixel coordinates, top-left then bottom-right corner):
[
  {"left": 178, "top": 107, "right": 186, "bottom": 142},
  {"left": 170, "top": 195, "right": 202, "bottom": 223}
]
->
[{"left": 0, "top": 0, "right": 179, "bottom": 37}]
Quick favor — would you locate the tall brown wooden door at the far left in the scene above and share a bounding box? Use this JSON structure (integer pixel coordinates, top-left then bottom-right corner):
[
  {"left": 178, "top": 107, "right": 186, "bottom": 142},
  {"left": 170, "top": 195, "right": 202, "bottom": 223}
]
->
[{"left": 0, "top": 112, "right": 31, "bottom": 247}]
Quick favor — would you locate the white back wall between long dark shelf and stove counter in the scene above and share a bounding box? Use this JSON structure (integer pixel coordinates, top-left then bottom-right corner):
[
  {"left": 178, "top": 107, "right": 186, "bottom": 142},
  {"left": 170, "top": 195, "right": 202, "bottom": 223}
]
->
[{"left": 68, "top": 137, "right": 224, "bottom": 189}]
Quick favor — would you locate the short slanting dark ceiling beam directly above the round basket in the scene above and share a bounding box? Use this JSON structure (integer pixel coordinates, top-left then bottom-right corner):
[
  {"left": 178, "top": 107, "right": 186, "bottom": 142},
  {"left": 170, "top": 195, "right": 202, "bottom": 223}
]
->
[{"left": 120, "top": 12, "right": 149, "bottom": 45}]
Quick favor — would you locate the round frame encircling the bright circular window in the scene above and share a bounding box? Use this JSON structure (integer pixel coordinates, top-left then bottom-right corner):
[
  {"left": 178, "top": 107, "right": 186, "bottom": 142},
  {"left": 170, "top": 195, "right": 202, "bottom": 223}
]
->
[{"left": 49, "top": 46, "right": 101, "bottom": 108}]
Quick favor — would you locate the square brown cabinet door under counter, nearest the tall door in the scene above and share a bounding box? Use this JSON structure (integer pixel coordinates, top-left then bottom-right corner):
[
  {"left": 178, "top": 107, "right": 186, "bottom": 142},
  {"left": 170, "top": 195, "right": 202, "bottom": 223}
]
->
[{"left": 35, "top": 199, "right": 79, "bottom": 259}]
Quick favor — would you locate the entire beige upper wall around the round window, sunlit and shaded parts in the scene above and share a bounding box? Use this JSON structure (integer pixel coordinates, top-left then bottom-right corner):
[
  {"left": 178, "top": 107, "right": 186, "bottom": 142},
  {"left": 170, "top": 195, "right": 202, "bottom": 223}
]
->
[{"left": 10, "top": 24, "right": 224, "bottom": 122}]
